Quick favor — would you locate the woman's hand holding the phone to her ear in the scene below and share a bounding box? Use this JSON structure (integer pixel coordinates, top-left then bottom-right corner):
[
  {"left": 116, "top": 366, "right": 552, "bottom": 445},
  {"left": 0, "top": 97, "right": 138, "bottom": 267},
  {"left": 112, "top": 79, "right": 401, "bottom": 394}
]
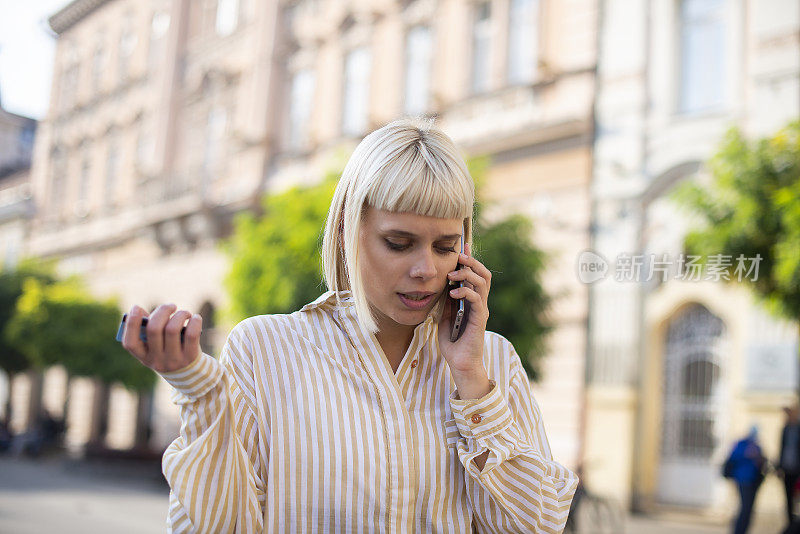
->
[{"left": 439, "top": 244, "right": 492, "bottom": 398}]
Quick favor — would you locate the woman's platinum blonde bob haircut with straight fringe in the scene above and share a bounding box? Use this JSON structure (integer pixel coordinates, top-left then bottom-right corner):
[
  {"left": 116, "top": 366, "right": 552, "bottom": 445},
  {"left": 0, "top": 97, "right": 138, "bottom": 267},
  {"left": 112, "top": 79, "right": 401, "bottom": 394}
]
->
[{"left": 322, "top": 119, "right": 475, "bottom": 333}]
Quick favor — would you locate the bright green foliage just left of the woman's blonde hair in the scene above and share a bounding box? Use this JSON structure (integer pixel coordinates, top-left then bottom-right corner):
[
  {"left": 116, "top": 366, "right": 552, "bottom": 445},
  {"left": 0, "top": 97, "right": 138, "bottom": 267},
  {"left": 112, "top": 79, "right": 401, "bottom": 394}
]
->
[{"left": 224, "top": 174, "right": 336, "bottom": 319}]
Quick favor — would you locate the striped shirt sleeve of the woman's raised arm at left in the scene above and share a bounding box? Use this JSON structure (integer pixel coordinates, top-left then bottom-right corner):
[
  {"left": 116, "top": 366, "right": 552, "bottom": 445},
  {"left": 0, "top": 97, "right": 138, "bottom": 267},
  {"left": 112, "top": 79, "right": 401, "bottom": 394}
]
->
[{"left": 161, "top": 329, "right": 265, "bottom": 533}]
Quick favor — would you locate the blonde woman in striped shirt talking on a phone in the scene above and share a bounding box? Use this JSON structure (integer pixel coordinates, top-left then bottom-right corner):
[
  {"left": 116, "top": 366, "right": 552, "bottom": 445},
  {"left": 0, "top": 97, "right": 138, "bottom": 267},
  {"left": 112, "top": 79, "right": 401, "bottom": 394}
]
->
[{"left": 123, "top": 120, "right": 577, "bottom": 533}]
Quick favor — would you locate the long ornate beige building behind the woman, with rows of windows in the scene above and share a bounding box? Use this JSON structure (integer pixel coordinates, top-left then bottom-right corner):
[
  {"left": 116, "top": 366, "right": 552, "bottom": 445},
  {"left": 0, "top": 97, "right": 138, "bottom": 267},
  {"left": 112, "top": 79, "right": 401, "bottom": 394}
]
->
[{"left": 15, "top": 0, "right": 596, "bottom": 482}]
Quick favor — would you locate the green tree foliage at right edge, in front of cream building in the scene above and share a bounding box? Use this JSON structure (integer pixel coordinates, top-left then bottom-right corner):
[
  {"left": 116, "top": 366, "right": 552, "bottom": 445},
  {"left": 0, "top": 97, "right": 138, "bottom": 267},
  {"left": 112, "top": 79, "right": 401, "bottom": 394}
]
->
[{"left": 674, "top": 122, "right": 800, "bottom": 320}]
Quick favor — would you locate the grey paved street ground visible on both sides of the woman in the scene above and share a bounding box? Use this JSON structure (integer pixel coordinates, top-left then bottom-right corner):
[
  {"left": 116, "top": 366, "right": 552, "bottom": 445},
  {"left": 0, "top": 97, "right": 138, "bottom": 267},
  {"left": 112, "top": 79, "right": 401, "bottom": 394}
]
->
[{"left": 0, "top": 456, "right": 780, "bottom": 534}]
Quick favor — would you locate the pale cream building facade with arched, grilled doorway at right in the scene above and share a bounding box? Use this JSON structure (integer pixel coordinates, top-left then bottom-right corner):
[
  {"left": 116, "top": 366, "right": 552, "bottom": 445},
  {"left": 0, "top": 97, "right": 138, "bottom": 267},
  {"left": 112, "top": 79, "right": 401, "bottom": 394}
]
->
[{"left": 584, "top": 0, "right": 800, "bottom": 518}]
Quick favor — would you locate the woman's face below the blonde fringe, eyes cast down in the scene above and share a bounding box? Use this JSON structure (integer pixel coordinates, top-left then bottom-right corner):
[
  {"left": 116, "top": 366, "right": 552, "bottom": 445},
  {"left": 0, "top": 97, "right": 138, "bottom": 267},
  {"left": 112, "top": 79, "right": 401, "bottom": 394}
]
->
[{"left": 359, "top": 208, "right": 463, "bottom": 329}]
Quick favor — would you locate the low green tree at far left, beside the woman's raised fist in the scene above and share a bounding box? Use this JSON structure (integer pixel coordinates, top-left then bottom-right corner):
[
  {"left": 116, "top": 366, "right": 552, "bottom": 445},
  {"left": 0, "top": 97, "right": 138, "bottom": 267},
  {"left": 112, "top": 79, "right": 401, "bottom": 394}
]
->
[{"left": 5, "top": 277, "right": 156, "bottom": 391}]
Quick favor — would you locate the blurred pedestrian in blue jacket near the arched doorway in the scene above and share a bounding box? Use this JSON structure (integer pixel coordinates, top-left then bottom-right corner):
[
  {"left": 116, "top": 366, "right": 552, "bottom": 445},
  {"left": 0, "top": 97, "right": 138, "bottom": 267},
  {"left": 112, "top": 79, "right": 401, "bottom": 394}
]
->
[{"left": 725, "top": 425, "right": 766, "bottom": 534}]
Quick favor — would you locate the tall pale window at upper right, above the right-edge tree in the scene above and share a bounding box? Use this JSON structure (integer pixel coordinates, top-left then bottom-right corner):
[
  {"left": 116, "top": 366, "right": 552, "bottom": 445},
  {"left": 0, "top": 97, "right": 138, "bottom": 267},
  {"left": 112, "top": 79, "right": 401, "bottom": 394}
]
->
[{"left": 678, "top": 0, "right": 727, "bottom": 113}]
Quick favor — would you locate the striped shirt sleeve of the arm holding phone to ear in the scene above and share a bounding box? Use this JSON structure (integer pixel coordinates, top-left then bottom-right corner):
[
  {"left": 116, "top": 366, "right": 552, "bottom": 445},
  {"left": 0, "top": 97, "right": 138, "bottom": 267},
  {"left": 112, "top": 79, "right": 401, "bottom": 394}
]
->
[{"left": 450, "top": 353, "right": 578, "bottom": 534}]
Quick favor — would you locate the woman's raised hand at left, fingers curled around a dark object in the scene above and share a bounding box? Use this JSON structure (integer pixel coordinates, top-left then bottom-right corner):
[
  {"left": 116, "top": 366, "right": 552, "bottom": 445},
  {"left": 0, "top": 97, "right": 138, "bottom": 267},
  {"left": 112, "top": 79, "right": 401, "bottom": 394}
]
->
[{"left": 122, "top": 304, "right": 203, "bottom": 373}]
